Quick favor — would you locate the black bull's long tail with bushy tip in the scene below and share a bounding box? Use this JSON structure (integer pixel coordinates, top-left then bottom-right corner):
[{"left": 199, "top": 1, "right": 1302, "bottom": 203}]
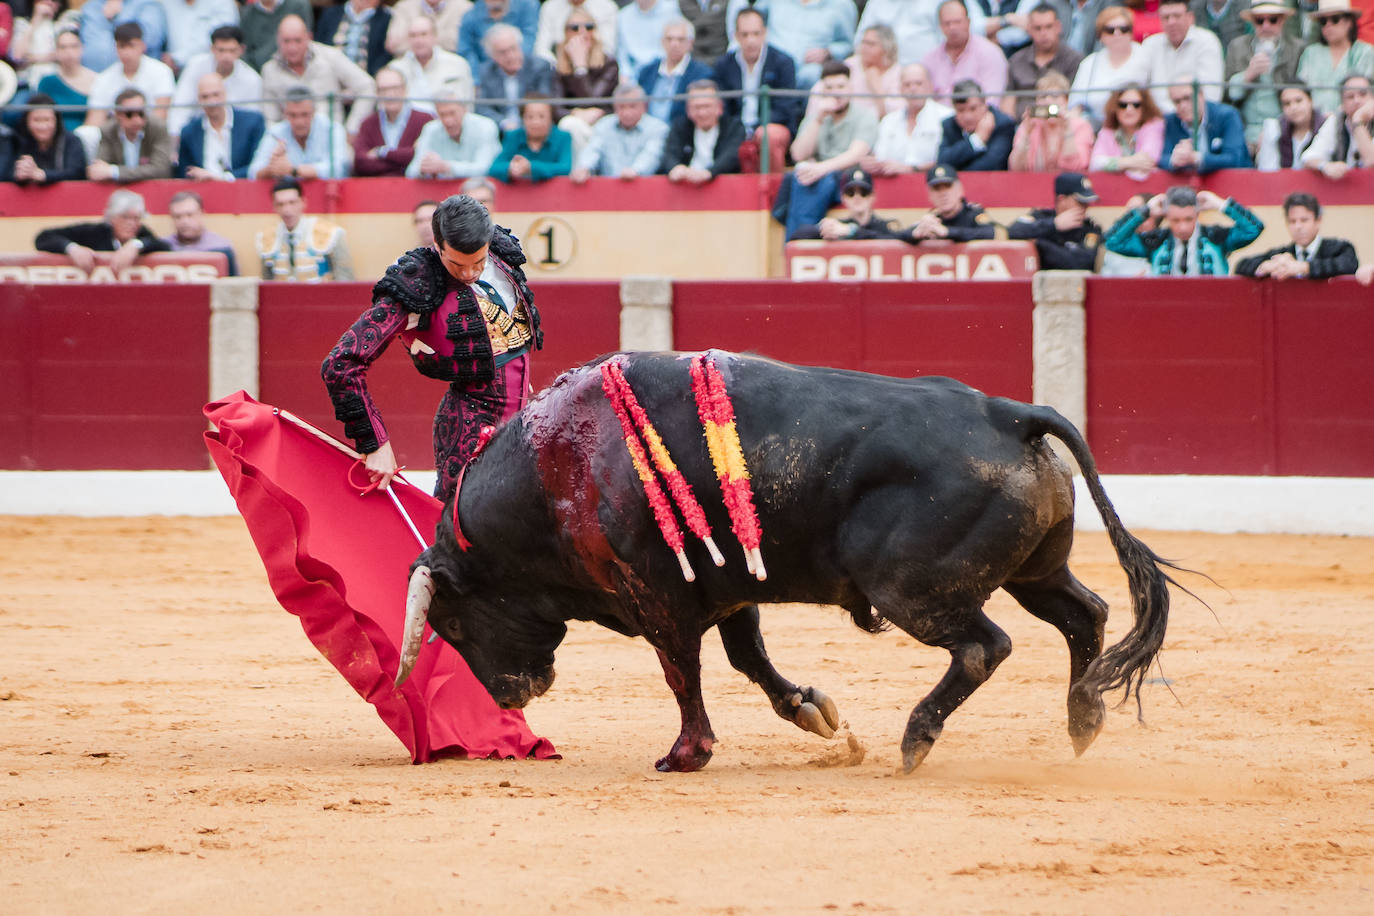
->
[{"left": 1026, "top": 407, "right": 1186, "bottom": 710}]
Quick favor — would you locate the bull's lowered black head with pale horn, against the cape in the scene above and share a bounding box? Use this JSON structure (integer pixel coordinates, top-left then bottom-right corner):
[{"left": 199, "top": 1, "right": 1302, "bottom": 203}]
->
[{"left": 396, "top": 548, "right": 567, "bottom": 709}]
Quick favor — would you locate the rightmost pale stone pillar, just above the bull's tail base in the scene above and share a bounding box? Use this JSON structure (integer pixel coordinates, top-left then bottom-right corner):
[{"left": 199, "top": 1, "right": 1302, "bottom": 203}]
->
[{"left": 1031, "top": 271, "right": 1091, "bottom": 466}]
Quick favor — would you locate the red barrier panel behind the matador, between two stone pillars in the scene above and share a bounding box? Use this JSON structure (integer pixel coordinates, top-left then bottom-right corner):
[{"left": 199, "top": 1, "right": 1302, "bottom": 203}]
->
[{"left": 258, "top": 282, "right": 620, "bottom": 468}]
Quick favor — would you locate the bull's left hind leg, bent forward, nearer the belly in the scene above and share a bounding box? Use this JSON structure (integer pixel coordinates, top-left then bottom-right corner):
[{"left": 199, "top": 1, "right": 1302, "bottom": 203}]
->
[{"left": 879, "top": 608, "right": 1011, "bottom": 773}]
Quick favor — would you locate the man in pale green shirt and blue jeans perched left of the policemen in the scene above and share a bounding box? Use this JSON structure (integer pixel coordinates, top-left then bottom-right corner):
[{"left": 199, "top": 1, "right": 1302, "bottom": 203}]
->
[{"left": 772, "top": 60, "right": 878, "bottom": 240}]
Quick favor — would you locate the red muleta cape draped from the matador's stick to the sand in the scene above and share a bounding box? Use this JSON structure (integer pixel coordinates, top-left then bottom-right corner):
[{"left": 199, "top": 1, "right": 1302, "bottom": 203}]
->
[{"left": 205, "top": 391, "right": 558, "bottom": 764}]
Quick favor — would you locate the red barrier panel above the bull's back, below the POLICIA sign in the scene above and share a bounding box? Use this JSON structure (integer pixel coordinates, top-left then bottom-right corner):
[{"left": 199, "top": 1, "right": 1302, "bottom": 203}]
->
[{"left": 673, "top": 280, "right": 1032, "bottom": 400}]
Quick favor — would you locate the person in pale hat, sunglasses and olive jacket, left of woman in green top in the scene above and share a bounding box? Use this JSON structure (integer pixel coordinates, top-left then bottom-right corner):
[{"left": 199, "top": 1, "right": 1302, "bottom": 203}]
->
[{"left": 1225, "top": 0, "right": 1303, "bottom": 150}]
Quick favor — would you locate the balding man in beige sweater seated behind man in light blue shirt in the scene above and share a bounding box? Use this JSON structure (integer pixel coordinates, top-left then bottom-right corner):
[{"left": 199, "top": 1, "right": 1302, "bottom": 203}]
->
[{"left": 262, "top": 16, "right": 376, "bottom": 136}]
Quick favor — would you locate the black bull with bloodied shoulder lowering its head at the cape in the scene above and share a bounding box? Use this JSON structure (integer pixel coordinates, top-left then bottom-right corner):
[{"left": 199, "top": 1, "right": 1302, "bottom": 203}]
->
[{"left": 398, "top": 352, "right": 1171, "bottom": 770}]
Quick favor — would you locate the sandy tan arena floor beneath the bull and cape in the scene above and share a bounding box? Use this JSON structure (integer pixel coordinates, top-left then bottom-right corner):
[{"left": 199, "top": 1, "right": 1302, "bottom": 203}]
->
[{"left": 0, "top": 518, "right": 1374, "bottom": 916}]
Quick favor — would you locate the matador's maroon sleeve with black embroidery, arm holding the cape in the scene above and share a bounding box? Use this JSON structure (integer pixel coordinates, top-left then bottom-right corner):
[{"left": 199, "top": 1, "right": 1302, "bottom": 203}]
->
[{"left": 320, "top": 298, "right": 409, "bottom": 455}]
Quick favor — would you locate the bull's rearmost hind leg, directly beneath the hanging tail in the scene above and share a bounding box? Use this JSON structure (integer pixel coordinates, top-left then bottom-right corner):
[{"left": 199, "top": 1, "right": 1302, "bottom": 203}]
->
[{"left": 1002, "top": 566, "right": 1107, "bottom": 754}]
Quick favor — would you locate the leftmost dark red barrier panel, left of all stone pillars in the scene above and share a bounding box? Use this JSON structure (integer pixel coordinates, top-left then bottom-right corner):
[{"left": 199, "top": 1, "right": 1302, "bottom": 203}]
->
[{"left": 0, "top": 284, "right": 210, "bottom": 471}]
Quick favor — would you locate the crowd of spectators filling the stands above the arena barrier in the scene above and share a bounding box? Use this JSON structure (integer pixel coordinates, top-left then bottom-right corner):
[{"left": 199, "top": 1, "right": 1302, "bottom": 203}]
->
[{"left": 0, "top": 0, "right": 1374, "bottom": 280}]
